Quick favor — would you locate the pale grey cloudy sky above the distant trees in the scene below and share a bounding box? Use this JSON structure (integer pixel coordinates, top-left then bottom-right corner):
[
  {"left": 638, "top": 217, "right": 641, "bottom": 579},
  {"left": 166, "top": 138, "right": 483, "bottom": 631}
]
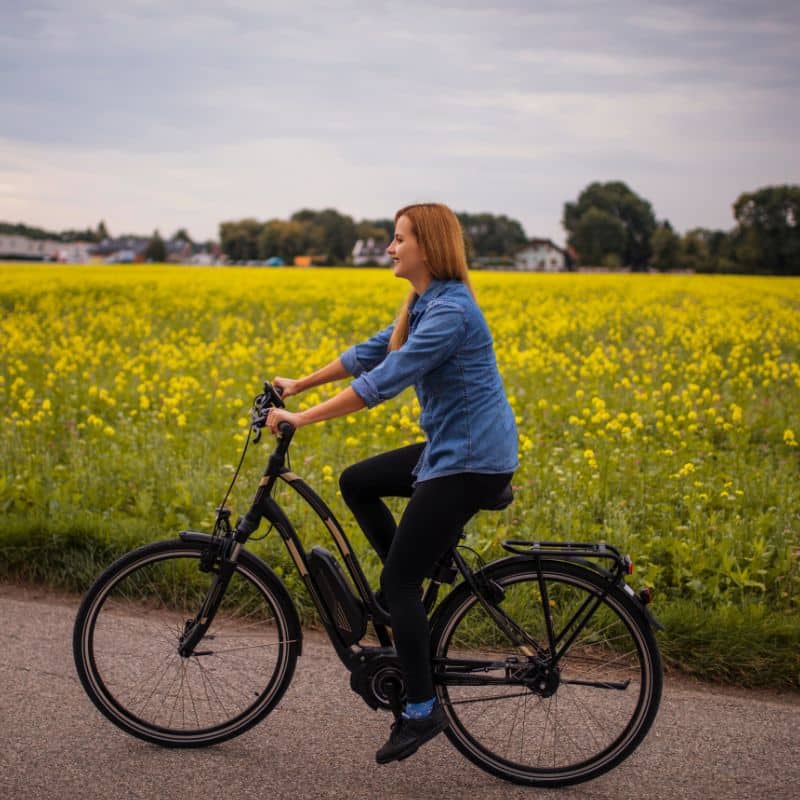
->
[{"left": 0, "top": 0, "right": 800, "bottom": 242}]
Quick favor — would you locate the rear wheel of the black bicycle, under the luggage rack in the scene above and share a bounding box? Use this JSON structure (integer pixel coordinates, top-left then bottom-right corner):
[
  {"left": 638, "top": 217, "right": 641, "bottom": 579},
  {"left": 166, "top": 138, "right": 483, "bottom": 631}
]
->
[{"left": 431, "top": 559, "right": 662, "bottom": 787}]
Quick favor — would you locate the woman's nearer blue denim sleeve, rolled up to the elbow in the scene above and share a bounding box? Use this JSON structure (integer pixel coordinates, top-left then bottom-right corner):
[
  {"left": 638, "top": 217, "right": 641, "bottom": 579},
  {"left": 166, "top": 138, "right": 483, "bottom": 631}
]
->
[{"left": 352, "top": 301, "right": 466, "bottom": 408}]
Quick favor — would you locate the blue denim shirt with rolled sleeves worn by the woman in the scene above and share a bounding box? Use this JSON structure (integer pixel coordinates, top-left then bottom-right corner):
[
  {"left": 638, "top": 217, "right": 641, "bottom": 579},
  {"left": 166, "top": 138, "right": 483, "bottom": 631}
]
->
[{"left": 341, "top": 280, "right": 518, "bottom": 481}]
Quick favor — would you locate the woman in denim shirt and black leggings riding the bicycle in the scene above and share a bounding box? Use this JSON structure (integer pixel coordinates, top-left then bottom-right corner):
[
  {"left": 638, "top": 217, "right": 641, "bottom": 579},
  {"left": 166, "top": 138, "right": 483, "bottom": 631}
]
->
[{"left": 267, "top": 203, "right": 518, "bottom": 764}]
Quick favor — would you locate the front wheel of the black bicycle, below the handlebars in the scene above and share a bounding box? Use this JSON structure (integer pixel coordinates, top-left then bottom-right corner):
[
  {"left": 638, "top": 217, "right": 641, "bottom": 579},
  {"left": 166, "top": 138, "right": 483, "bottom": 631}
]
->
[{"left": 73, "top": 539, "right": 301, "bottom": 747}]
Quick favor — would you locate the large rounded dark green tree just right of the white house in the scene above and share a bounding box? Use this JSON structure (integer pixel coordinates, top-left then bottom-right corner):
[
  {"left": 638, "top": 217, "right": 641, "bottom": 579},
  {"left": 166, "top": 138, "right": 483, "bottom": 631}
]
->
[{"left": 562, "top": 181, "right": 656, "bottom": 269}]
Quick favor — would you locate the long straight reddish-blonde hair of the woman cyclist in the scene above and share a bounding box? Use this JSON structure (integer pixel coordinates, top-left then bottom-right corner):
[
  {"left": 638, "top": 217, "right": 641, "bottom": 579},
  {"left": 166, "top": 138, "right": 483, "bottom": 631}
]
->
[{"left": 389, "top": 203, "right": 475, "bottom": 350}]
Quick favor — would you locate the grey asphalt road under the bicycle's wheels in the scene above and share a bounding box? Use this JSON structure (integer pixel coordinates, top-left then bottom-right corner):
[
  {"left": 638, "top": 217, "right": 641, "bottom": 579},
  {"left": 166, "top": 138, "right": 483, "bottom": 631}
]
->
[{"left": 0, "top": 584, "right": 800, "bottom": 800}]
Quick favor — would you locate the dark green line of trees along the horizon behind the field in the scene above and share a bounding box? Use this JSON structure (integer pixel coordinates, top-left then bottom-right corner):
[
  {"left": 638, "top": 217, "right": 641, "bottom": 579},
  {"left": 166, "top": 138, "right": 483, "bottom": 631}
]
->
[{"left": 0, "top": 181, "right": 800, "bottom": 275}]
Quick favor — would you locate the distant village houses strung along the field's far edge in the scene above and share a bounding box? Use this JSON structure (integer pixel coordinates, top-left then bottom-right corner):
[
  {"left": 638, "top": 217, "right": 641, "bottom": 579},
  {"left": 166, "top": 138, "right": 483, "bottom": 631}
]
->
[{"left": 0, "top": 233, "right": 574, "bottom": 272}]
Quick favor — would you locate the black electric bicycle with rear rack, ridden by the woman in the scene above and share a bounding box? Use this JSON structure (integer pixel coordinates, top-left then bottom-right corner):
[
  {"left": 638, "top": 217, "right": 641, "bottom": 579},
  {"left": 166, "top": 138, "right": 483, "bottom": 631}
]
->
[{"left": 73, "top": 383, "right": 662, "bottom": 787}]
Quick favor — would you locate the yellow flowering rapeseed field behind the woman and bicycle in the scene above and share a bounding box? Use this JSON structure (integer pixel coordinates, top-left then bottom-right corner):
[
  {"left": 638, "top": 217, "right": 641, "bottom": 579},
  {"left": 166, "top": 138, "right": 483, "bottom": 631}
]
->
[{"left": 0, "top": 265, "right": 800, "bottom": 675}]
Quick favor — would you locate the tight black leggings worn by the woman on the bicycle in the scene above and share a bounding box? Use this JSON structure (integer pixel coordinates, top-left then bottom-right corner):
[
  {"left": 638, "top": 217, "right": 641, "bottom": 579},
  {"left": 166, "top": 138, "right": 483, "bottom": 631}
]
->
[{"left": 339, "top": 444, "right": 511, "bottom": 703}]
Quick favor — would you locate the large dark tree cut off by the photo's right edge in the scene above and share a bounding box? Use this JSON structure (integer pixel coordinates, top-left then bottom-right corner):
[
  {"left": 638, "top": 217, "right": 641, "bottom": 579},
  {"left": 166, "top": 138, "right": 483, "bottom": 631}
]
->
[{"left": 733, "top": 185, "right": 800, "bottom": 275}]
